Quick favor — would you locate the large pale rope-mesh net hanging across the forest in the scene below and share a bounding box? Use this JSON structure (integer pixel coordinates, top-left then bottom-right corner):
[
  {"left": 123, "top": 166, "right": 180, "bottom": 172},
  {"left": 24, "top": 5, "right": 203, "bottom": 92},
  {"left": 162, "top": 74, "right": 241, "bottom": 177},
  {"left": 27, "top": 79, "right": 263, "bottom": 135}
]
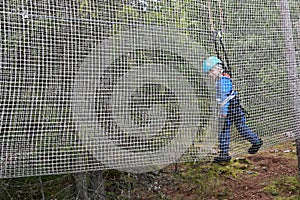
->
[{"left": 0, "top": 0, "right": 300, "bottom": 178}]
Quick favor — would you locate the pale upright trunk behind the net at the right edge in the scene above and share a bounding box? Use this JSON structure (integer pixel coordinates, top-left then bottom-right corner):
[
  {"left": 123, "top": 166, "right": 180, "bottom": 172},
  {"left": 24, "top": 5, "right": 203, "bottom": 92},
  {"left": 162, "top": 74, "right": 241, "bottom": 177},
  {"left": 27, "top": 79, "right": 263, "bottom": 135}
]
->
[{"left": 280, "top": 0, "right": 300, "bottom": 175}]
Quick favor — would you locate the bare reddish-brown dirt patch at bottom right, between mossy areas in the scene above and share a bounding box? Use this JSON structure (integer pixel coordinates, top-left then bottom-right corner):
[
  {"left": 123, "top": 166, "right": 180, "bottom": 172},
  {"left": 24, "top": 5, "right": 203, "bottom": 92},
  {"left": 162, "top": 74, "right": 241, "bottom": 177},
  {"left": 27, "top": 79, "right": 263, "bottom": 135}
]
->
[{"left": 222, "top": 146, "right": 300, "bottom": 199}]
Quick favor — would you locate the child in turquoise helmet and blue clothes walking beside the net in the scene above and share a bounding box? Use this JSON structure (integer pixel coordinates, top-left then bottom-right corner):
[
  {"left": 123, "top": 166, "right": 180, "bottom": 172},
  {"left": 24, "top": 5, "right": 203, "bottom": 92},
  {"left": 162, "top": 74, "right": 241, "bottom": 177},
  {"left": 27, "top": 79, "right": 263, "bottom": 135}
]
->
[{"left": 202, "top": 56, "right": 263, "bottom": 163}]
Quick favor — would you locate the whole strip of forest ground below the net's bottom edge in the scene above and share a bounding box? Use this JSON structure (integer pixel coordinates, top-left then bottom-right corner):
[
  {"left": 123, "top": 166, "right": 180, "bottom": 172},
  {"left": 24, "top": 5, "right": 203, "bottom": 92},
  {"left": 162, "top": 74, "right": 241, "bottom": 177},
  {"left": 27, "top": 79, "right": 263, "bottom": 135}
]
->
[{"left": 0, "top": 142, "right": 300, "bottom": 200}]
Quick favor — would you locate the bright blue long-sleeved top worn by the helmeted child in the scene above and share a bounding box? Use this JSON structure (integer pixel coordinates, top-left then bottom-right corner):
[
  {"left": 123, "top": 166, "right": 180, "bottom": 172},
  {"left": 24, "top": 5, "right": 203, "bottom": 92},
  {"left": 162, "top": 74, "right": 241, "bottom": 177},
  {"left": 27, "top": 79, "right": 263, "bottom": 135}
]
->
[{"left": 216, "top": 76, "right": 236, "bottom": 115}]
